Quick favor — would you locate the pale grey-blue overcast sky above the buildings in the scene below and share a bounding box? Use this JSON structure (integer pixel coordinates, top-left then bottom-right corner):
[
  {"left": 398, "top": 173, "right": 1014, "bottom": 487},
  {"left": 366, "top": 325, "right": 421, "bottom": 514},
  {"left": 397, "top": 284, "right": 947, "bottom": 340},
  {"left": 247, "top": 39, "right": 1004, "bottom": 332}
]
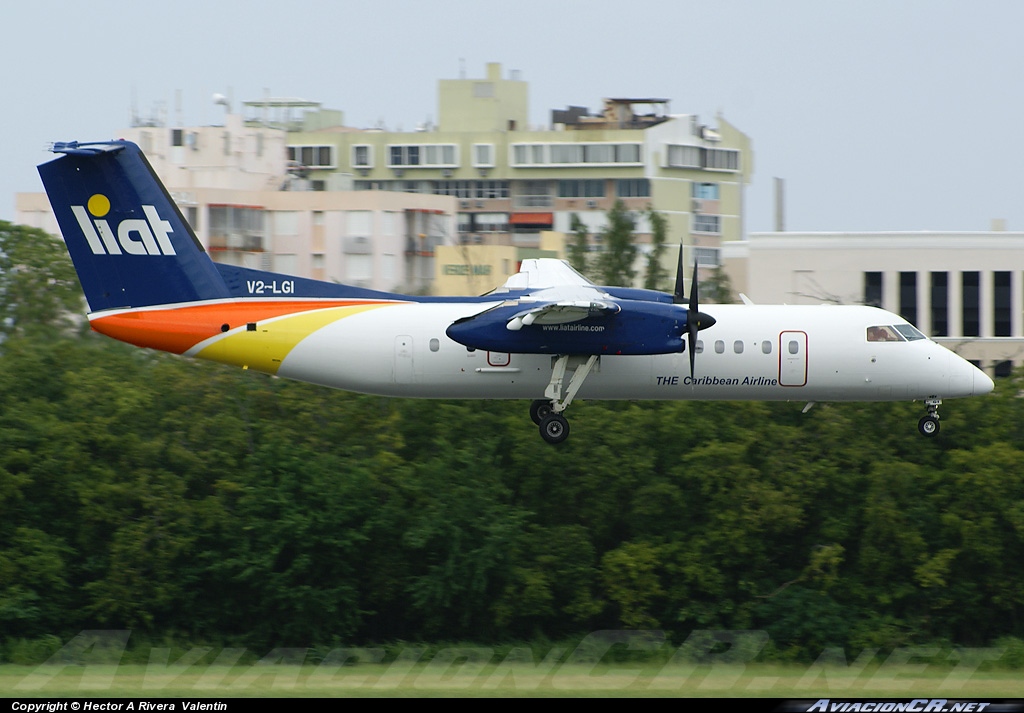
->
[{"left": 0, "top": 0, "right": 1024, "bottom": 232}]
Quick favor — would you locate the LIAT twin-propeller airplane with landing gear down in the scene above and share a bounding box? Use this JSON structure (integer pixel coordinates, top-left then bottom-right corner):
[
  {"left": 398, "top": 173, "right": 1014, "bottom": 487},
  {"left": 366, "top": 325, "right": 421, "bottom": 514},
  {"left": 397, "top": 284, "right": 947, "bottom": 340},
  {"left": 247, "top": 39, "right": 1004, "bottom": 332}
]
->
[{"left": 39, "top": 140, "right": 993, "bottom": 444}]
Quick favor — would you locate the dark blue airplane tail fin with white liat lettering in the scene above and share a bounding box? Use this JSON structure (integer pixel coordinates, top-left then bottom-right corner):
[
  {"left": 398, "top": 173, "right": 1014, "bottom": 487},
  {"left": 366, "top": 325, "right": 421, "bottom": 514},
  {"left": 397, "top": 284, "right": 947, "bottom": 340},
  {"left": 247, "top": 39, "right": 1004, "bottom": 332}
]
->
[{"left": 39, "top": 141, "right": 230, "bottom": 311}]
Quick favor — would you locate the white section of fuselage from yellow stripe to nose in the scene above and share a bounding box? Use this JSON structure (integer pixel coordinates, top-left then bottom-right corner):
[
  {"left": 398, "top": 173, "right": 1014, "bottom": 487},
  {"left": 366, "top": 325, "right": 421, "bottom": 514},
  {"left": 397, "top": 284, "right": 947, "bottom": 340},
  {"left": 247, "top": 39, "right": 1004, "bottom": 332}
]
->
[{"left": 261, "top": 302, "right": 992, "bottom": 402}]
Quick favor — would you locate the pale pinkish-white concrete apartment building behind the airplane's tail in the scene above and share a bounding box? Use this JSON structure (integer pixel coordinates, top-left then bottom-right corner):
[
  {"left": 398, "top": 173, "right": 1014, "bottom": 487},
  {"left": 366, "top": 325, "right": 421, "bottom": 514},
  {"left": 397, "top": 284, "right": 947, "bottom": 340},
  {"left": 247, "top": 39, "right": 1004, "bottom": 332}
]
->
[{"left": 15, "top": 115, "right": 457, "bottom": 292}]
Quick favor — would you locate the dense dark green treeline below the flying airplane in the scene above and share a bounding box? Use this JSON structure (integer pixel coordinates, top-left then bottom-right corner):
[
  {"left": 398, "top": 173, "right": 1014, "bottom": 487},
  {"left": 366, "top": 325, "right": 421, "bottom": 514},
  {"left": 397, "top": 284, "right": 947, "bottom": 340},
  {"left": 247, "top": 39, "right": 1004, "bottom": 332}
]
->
[{"left": 0, "top": 224, "right": 1024, "bottom": 659}]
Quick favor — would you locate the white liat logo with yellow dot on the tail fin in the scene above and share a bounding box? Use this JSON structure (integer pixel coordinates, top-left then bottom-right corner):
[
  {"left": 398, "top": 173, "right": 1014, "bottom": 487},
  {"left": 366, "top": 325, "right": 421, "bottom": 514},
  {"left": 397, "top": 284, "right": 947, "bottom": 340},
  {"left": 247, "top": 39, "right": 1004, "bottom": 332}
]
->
[{"left": 71, "top": 194, "right": 176, "bottom": 255}]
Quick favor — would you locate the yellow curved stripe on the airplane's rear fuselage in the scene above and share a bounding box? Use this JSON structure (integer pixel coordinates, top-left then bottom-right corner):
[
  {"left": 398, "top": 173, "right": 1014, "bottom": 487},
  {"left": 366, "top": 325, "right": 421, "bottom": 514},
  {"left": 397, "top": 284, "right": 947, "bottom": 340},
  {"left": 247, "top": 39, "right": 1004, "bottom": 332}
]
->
[{"left": 196, "top": 304, "right": 391, "bottom": 374}]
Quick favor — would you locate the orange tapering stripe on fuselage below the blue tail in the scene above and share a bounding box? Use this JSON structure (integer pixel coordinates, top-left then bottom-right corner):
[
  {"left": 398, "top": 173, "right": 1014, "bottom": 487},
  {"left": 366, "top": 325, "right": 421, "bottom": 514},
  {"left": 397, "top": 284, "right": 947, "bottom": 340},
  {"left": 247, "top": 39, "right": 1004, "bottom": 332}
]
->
[{"left": 91, "top": 299, "right": 399, "bottom": 354}]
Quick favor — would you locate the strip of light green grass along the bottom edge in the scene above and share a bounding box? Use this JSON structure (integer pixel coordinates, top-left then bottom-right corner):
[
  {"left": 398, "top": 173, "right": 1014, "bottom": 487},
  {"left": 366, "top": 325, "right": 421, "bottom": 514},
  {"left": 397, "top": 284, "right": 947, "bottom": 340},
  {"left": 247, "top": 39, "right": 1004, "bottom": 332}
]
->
[{"left": 0, "top": 657, "right": 1024, "bottom": 701}]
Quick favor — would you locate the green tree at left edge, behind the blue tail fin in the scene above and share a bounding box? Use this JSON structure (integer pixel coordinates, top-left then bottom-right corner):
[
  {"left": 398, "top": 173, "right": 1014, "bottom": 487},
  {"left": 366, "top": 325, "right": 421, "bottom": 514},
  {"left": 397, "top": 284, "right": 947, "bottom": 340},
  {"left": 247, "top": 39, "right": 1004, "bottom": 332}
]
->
[{"left": 0, "top": 220, "right": 82, "bottom": 335}]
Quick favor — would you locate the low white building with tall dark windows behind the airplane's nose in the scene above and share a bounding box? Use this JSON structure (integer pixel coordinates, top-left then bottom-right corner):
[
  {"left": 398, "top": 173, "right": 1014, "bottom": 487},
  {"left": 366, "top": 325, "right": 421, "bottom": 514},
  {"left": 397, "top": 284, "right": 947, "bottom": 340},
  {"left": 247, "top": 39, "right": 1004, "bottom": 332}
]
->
[{"left": 723, "top": 232, "right": 1024, "bottom": 375}]
